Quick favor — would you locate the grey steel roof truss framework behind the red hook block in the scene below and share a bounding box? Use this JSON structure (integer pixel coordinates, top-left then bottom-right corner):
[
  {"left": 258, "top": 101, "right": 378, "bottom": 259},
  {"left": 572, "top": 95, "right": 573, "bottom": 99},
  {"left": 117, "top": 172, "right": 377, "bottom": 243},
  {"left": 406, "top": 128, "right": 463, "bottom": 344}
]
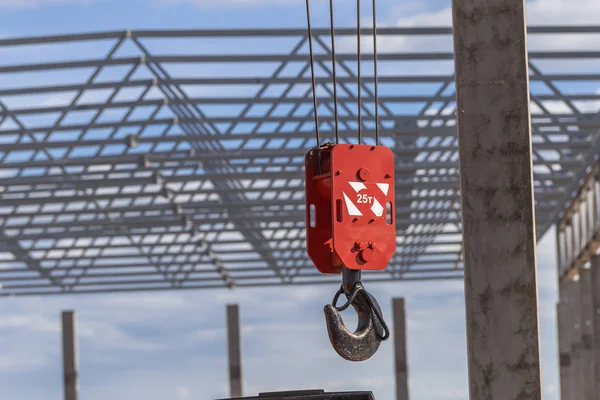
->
[{"left": 0, "top": 27, "right": 600, "bottom": 296}]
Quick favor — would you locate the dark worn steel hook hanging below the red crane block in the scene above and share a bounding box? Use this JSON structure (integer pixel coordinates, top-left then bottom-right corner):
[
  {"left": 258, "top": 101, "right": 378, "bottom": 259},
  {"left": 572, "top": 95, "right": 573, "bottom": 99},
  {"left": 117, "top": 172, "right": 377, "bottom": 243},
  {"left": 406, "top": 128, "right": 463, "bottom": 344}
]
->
[{"left": 324, "top": 283, "right": 389, "bottom": 361}]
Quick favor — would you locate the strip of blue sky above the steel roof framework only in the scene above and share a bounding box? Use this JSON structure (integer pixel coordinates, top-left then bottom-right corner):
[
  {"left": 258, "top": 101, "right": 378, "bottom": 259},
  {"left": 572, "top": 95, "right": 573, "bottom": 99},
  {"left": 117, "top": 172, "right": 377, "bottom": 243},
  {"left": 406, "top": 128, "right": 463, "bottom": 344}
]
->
[{"left": 0, "top": 0, "right": 599, "bottom": 36}]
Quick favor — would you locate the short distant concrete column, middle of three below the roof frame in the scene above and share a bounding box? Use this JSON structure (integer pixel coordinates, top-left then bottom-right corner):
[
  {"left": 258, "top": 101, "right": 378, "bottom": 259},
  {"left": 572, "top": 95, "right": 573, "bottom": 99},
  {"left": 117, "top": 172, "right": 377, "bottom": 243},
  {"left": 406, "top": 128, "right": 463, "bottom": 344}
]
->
[{"left": 227, "top": 304, "right": 242, "bottom": 397}]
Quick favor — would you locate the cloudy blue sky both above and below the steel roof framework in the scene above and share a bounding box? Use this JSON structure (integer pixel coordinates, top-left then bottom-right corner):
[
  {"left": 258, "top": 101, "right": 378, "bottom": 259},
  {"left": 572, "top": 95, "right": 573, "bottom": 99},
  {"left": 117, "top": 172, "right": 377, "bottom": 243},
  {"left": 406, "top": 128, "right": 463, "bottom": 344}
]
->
[{"left": 0, "top": 0, "right": 600, "bottom": 400}]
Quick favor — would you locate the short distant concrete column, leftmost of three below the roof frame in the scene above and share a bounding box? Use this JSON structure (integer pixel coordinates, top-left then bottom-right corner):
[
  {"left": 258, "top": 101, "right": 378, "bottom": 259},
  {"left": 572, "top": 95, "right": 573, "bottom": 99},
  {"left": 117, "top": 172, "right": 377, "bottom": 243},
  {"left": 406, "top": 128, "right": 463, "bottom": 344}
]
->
[{"left": 62, "top": 311, "right": 79, "bottom": 400}]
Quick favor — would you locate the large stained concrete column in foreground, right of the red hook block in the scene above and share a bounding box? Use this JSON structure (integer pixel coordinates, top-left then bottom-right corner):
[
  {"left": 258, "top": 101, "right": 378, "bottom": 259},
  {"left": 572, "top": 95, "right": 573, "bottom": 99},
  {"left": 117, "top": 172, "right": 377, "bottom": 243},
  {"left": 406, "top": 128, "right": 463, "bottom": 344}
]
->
[{"left": 452, "top": 0, "right": 542, "bottom": 400}]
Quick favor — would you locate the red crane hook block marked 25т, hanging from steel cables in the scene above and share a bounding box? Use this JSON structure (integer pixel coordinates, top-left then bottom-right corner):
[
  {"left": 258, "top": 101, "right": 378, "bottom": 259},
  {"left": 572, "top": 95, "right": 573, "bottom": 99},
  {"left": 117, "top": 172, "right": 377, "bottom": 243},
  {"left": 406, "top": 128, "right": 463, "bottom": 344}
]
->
[{"left": 305, "top": 143, "right": 396, "bottom": 274}]
